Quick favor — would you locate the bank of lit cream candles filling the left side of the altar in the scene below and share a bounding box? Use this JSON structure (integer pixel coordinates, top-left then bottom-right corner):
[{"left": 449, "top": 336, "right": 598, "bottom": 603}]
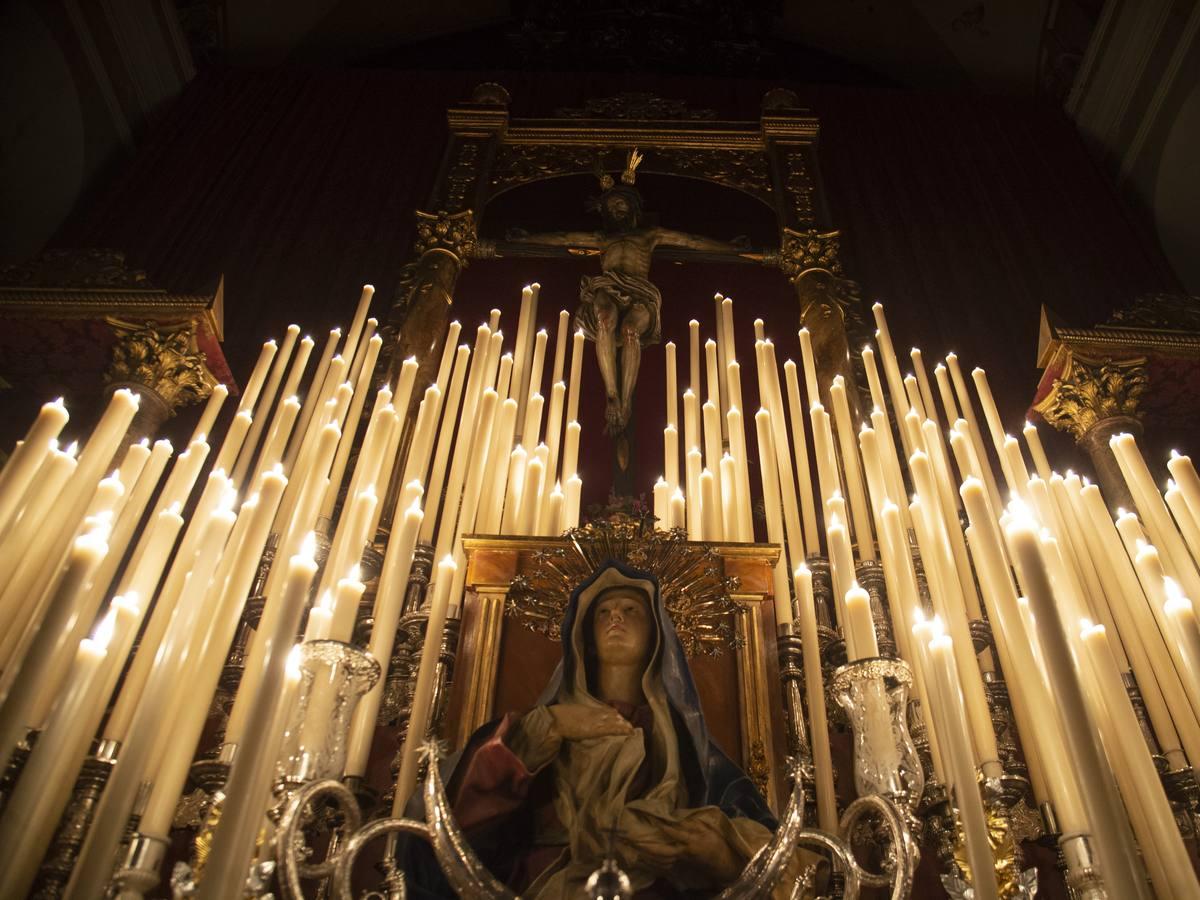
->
[{"left": 0, "top": 278, "right": 595, "bottom": 898}]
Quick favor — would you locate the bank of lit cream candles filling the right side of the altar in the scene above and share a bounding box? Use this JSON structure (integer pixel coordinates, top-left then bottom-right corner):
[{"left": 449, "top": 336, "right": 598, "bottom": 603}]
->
[{"left": 654, "top": 292, "right": 1200, "bottom": 896}]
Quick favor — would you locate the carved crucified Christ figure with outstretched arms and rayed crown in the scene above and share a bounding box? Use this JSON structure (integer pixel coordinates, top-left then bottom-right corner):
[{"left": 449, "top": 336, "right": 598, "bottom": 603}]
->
[{"left": 506, "top": 149, "right": 746, "bottom": 434}]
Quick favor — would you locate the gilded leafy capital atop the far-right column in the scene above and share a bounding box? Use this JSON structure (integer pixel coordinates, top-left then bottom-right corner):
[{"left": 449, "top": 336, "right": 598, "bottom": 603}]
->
[{"left": 1033, "top": 354, "right": 1150, "bottom": 440}]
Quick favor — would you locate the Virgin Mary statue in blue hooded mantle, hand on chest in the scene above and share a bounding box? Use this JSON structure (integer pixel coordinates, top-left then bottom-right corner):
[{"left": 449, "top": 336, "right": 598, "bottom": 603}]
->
[{"left": 406, "top": 562, "right": 788, "bottom": 900}]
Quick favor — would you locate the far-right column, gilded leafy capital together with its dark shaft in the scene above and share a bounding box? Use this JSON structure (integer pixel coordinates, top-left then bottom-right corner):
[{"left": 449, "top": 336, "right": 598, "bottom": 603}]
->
[{"left": 1033, "top": 352, "right": 1150, "bottom": 509}]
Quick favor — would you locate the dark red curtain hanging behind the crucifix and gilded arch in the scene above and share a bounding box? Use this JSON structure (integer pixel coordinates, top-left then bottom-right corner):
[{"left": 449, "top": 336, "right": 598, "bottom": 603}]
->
[{"left": 56, "top": 70, "right": 1175, "bottom": 487}]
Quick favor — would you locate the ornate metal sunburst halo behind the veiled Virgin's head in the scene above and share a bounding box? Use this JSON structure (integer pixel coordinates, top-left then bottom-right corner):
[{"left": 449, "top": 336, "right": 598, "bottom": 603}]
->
[{"left": 505, "top": 515, "right": 738, "bottom": 656}]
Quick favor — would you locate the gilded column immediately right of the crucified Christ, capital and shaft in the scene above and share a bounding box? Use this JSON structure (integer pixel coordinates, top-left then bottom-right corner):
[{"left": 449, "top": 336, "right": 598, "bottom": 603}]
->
[{"left": 778, "top": 228, "right": 860, "bottom": 420}]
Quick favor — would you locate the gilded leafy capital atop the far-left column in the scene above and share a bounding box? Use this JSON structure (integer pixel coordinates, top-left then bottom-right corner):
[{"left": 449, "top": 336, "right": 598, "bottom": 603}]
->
[{"left": 106, "top": 319, "right": 216, "bottom": 414}]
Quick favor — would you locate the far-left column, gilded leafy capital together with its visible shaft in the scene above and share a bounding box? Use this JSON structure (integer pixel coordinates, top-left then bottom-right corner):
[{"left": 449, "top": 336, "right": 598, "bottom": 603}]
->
[{"left": 104, "top": 318, "right": 216, "bottom": 442}]
